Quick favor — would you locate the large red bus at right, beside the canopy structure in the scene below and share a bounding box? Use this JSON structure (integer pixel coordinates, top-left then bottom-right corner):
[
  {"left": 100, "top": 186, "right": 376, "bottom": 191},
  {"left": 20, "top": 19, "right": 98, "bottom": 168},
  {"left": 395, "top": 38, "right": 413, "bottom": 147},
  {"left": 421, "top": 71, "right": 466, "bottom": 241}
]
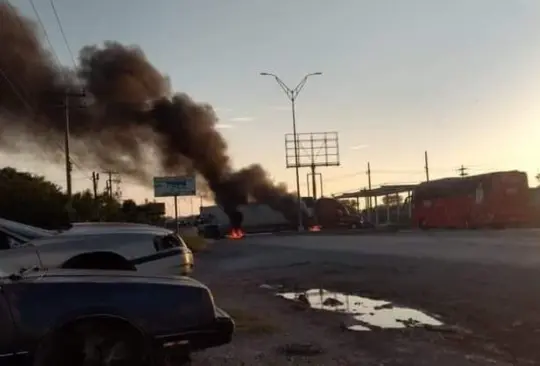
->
[{"left": 412, "top": 171, "right": 530, "bottom": 229}]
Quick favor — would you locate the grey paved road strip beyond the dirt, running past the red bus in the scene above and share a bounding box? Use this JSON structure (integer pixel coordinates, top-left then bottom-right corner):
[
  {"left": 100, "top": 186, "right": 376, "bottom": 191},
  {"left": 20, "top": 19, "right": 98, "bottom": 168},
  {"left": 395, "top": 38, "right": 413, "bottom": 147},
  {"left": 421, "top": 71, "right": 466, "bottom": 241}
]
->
[{"left": 215, "top": 230, "right": 540, "bottom": 269}]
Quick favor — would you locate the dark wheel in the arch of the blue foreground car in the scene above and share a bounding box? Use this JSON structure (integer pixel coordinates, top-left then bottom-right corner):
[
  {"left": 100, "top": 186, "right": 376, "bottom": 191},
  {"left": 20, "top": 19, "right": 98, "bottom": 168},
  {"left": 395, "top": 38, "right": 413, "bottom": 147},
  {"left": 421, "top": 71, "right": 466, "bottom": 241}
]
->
[{"left": 34, "top": 320, "right": 154, "bottom": 366}]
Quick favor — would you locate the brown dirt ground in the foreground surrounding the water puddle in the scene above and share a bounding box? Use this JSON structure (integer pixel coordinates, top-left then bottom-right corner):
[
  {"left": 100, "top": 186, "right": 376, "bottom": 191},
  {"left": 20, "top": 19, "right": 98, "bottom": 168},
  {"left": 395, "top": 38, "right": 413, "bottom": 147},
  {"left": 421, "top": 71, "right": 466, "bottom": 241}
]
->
[{"left": 187, "top": 243, "right": 540, "bottom": 366}]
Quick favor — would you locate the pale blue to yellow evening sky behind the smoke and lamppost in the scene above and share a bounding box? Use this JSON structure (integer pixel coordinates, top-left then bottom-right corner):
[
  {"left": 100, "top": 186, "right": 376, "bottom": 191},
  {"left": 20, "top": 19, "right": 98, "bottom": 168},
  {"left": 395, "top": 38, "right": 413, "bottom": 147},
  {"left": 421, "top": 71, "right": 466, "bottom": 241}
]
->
[{"left": 0, "top": 0, "right": 540, "bottom": 214}]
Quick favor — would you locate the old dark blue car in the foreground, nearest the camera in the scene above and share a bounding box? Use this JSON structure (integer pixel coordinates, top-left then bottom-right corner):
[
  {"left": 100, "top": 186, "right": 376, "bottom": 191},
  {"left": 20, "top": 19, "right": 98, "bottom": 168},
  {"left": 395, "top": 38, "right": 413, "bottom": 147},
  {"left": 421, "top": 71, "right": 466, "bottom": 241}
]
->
[{"left": 0, "top": 266, "right": 234, "bottom": 366}]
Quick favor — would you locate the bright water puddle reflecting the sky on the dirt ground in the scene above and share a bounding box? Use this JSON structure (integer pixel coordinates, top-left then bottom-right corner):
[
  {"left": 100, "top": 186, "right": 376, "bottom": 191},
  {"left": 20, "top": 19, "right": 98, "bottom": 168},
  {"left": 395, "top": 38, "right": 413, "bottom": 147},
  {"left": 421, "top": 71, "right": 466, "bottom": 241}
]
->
[{"left": 272, "top": 286, "right": 443, "bottom": 331}]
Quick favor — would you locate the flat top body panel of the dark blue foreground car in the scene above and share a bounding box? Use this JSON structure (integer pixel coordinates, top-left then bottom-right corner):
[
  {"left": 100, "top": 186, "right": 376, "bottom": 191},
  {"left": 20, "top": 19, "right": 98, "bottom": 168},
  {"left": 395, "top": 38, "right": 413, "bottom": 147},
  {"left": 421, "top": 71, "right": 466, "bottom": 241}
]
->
[{"left": 22, "top": 269, "right": 206, "bottom": 287}]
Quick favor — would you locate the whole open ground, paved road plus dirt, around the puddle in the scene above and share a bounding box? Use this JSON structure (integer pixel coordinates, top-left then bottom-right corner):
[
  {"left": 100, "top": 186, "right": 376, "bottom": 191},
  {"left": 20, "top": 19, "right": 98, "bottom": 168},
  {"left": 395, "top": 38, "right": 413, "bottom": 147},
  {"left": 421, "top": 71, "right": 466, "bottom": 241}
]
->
[{"left": 185, "top": 232, "right": 540, "bottom": 366}]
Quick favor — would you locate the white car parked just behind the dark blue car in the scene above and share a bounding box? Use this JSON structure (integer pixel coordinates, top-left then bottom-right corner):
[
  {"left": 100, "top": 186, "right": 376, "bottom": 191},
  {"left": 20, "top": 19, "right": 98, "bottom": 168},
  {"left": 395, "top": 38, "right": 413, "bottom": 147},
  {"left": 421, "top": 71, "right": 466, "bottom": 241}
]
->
[{"left": 0, "top": 220, "right": 194, "bottom": 275}]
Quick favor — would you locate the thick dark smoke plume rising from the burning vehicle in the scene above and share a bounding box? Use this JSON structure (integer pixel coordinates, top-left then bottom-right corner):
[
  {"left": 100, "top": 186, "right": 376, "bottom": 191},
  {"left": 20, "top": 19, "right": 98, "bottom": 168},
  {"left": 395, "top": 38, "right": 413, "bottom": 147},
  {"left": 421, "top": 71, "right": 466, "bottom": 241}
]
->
[{"left": 0, "top": 3, "right": 304, "bottom": 221}]
